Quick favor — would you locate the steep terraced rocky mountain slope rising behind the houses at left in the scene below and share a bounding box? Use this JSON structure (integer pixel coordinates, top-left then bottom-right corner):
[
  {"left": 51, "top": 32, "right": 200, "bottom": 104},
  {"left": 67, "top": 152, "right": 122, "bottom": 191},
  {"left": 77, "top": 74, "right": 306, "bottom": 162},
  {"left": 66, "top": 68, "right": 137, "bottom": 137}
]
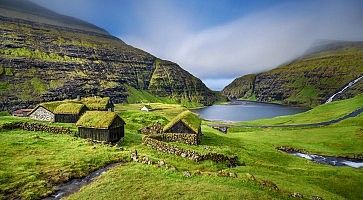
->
[{"left": 0, "top": 0, "right": 216, "bottom": 110}]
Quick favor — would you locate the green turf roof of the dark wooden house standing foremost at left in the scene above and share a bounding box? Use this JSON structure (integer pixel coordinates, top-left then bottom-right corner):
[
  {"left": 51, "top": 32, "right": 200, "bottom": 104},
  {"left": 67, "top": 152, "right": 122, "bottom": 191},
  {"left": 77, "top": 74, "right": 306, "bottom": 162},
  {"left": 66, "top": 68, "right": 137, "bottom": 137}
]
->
[{"left": 76, "top": 111, "right": 123, "bottom": 128}]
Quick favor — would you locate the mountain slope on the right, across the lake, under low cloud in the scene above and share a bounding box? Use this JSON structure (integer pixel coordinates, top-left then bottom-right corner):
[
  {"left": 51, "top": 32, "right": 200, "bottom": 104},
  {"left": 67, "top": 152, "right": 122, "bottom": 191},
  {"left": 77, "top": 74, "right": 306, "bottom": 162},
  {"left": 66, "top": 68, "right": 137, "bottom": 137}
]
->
[{"left": 222, "top": 42, "right": 363, "bottom": 107}]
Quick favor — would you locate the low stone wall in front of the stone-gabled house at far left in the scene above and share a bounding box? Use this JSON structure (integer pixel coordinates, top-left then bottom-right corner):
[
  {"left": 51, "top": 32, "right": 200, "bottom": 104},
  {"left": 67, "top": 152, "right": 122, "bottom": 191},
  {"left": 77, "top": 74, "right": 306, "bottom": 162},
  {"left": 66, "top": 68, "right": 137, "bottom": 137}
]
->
[{"left": 0, "top": 122, "right": 77, "bottom": 135}]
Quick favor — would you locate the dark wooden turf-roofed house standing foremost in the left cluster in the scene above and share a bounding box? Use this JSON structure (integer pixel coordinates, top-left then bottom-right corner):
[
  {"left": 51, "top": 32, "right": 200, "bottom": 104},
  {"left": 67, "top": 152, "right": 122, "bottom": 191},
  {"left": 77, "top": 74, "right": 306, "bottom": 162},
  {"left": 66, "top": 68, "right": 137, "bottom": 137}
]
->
[{"left": 76, "top": 111, "right": 125, "bottom": 142}]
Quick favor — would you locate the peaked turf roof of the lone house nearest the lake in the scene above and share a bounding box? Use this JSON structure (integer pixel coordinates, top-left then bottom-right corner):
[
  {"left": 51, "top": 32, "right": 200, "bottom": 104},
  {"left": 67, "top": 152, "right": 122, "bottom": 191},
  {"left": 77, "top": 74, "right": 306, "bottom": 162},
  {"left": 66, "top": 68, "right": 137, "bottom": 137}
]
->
[{"left": 163, "top": 110, "right": 202, "bottom": 133}]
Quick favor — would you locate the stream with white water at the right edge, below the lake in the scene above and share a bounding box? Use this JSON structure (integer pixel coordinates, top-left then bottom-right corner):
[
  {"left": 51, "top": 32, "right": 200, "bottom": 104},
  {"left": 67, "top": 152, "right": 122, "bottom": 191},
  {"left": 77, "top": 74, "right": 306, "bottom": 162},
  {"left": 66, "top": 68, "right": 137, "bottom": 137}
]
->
[{"left": 284, "top": 151, "right": 363, "bottom": 168}]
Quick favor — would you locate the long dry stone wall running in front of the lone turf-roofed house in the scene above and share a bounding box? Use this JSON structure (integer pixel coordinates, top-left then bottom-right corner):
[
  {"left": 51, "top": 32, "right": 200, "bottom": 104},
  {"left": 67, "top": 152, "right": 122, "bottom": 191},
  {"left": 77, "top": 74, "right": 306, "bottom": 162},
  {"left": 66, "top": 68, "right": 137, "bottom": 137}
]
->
[{"left": 142, "top": 136, "right": 240, "bottom": 167}]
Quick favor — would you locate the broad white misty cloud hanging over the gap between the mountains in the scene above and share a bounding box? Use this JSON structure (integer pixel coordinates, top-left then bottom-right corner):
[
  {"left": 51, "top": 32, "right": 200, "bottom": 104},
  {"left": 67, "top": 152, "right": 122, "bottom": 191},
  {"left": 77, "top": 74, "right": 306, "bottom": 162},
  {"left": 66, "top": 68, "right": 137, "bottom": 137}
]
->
[{"left": 120, "top": 1, "right": 363, "bottom": 89}]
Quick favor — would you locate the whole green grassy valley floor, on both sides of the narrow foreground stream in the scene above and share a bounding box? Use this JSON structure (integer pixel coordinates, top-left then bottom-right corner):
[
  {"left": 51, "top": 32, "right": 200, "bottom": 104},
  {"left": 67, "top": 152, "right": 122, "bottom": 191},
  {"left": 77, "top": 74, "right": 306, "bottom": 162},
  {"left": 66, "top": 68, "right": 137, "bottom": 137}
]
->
[{"left": 0, "top": 96, "right": 363, "bottom": 199}]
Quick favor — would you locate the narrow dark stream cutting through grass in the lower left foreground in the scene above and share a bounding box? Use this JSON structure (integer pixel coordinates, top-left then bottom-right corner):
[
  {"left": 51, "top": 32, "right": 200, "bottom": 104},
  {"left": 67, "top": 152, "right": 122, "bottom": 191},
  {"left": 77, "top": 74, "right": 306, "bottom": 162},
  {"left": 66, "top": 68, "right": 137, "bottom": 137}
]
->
[{"left": 44, "top": 163, "right": 120, "bottom": 200}]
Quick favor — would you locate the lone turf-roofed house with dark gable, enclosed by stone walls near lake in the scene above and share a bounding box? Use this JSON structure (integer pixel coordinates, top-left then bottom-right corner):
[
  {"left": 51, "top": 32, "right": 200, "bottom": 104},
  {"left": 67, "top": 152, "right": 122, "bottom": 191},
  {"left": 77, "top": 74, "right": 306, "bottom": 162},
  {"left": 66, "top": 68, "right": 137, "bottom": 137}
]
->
[{"left": 163, "top": 111, "right": 202, "bottom": 144}]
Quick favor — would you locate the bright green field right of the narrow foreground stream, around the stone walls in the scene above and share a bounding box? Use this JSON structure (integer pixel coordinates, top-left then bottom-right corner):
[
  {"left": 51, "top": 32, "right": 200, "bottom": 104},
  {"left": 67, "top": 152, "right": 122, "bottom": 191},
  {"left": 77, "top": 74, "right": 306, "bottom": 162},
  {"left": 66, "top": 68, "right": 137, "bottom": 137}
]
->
[{"left": 70, "top": 100, "right": 363, "bottom": 199}]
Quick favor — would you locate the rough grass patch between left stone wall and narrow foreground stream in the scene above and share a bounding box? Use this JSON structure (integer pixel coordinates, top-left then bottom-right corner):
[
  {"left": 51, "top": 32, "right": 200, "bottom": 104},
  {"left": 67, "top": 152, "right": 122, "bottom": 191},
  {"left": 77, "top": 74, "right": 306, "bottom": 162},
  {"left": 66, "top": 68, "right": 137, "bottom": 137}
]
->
[{"left": 0, "top": 130, "right": 125, "bottom": 199}]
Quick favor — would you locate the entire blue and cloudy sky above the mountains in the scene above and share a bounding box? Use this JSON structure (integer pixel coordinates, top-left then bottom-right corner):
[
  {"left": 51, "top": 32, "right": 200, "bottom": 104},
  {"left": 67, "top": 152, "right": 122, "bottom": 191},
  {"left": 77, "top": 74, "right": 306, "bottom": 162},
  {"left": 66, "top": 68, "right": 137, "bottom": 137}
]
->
[{"left": 32, "top": 0, "right": 363, "bottom": 90}]
